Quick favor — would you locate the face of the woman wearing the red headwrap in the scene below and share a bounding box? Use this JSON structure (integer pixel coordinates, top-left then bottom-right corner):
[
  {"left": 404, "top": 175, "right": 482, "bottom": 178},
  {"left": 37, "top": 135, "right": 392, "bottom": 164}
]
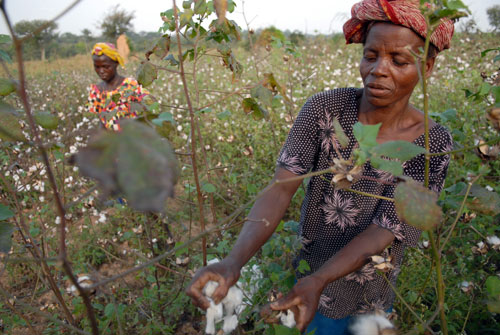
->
[{"left": 360, "top": 22, "right": 434, "bottom": 108}]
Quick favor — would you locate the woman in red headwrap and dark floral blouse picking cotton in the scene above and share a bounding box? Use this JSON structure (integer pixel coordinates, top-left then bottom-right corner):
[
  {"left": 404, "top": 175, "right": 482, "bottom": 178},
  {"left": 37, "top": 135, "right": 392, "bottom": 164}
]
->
[{"left": 187, "top": 0, "right": 453, "bottom": 335}]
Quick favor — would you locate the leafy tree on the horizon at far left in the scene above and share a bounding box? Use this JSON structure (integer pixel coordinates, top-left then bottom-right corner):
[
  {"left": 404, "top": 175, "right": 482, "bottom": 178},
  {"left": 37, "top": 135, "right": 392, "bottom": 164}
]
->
[{"left": 14, "top": 20, "right": 58, "bottom": 60}]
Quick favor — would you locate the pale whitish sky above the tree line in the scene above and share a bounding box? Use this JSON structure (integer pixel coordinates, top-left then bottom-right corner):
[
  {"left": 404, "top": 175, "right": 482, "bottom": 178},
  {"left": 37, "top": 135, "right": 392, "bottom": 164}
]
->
[{"left": 0, "top": 0, "right": 500, "bottom": 36}]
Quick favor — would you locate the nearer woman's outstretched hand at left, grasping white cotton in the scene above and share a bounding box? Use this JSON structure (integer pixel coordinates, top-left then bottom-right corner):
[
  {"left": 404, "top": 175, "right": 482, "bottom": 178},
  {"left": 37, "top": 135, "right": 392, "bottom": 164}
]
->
[{"left": 186, "top": 259, "right": 240, "bottom": 310}]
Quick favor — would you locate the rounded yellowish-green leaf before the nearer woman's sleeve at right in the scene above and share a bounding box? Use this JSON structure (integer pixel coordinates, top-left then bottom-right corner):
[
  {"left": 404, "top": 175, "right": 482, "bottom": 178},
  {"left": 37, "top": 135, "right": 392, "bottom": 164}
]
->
[{"left": 394, "top": 179, "right": 443, "bottom": 230}]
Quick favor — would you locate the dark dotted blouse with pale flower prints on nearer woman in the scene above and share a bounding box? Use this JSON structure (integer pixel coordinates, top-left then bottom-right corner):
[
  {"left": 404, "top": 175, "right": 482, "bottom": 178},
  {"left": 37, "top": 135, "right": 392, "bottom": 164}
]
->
[{"left": 277, "top": 88, "right": 453, "bottom": 319}]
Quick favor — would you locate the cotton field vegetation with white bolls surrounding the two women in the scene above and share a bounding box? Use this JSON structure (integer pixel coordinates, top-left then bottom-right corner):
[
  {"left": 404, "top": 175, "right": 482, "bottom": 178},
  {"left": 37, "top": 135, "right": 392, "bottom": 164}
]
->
[{"left": 0, "top": 1, "right": 500, "bottom": 334}]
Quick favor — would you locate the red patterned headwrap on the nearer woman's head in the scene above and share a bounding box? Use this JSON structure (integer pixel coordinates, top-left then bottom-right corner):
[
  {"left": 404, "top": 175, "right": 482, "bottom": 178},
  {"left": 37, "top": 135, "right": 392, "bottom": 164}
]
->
[{"left": 344, "top": 0, "right": 454, "bottom": 51}]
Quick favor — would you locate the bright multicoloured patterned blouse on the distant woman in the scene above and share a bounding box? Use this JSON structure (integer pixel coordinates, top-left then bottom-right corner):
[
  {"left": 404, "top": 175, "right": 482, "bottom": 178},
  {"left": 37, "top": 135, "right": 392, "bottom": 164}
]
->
[{"left": 87, "top": 78, "right": 149, "bottom": 130}]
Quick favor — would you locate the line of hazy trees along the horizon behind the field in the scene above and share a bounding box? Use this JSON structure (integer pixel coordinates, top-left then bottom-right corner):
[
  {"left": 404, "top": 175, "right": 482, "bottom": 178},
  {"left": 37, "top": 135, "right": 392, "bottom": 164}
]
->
[{"left": 3, "top": 5, "right": 500, "bottom": 60}]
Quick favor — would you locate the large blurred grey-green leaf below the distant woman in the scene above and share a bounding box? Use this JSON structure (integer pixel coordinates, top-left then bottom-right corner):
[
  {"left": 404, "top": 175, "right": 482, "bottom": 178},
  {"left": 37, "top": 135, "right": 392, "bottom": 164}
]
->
[{"left": 73, "top": 119, "right": 178, "bottom": 212}]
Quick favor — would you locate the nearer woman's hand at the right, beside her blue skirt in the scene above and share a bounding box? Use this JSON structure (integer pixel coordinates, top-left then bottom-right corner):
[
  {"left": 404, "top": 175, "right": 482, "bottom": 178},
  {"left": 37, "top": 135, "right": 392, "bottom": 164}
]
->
[{"left": 270, "top": 275, "right": 324, "bottom": 332}]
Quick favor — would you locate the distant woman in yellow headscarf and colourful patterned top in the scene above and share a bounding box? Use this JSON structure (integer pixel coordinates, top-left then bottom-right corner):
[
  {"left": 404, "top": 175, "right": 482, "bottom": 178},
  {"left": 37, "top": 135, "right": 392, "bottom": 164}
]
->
[{"left": 87, "top": 43, "right": 149, "bottom": 130}]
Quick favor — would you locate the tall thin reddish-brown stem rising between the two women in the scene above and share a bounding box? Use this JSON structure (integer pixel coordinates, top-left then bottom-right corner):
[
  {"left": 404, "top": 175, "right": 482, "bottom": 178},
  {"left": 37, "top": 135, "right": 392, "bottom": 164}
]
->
[{"left": 172, "top": 0, "right": 207, "bottom": 265}]
